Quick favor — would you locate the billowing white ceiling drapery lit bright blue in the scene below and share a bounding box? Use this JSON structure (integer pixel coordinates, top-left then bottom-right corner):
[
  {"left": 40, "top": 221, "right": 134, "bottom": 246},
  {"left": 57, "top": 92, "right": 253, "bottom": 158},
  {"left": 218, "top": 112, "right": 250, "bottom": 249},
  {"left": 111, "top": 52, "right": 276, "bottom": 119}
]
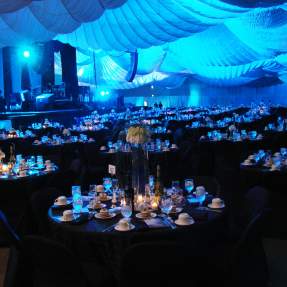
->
[{"left": 0, "top": 0, "right": 287, "bottom": 89}]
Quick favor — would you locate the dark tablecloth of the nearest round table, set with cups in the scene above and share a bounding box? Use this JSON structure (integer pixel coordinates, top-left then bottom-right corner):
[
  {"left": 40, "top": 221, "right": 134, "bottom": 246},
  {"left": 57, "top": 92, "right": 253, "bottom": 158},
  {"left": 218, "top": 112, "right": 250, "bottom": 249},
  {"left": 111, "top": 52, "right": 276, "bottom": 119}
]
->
[{"left": 48, "top": 197, "right": 225, "bottom": 277}]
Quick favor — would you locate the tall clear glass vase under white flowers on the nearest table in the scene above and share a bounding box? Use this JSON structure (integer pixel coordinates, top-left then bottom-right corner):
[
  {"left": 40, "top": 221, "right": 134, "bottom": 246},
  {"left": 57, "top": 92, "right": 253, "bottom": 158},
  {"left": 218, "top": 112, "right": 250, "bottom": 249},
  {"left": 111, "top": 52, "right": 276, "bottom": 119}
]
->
[{"left": 131, "top": 144, "right": 149, "bottom": 196}]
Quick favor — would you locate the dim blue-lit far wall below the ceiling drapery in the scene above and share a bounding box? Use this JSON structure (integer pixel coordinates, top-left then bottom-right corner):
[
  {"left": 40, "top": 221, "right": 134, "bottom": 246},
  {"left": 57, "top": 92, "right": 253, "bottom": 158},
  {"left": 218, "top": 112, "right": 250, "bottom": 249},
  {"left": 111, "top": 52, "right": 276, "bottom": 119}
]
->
[{"left": 123, "top": 82, "right": 287, "bottom": 107}]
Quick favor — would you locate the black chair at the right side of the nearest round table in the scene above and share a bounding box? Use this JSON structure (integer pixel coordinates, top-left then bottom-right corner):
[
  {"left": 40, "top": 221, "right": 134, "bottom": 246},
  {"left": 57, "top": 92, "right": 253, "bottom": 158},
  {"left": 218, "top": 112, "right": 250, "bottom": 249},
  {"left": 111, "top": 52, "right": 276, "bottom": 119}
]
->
[{"left": 199, "top": 187, "right": 269, "bottom": 287}]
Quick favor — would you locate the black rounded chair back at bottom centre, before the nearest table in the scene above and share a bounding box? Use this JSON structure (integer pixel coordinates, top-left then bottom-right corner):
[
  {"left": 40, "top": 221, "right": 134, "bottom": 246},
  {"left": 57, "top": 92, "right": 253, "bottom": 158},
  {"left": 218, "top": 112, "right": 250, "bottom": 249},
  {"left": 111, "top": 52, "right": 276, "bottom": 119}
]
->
[{"left": 120, "top": 241, "right": 199, "bottom": 286}]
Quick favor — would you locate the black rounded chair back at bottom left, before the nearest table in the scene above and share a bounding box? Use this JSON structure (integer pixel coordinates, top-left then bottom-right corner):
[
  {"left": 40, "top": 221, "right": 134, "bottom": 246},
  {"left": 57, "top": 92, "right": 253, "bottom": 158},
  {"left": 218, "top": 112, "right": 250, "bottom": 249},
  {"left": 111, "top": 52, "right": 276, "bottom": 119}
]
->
[{"left": 22, "top": 236, "right": 87, "bottom": 287}]
